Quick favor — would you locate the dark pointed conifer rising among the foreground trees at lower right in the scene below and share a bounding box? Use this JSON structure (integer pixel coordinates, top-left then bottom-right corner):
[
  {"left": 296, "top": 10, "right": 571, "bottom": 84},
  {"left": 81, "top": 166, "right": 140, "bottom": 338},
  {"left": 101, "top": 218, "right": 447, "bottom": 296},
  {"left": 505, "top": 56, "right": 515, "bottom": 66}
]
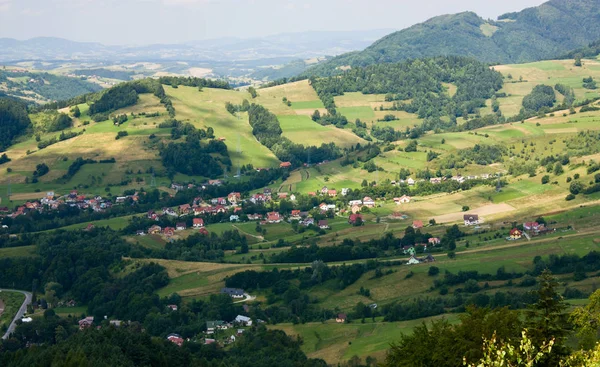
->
[{"left": 525, "top": 269, "right": 569, "bottom": 366}]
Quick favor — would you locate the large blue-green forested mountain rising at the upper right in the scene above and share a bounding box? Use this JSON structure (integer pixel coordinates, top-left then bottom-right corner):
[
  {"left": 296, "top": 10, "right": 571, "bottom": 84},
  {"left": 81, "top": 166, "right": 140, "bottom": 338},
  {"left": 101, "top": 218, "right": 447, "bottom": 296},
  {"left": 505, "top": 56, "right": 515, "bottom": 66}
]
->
[{"left": 307, "top": 0, "right": 600, "bottom": 75}]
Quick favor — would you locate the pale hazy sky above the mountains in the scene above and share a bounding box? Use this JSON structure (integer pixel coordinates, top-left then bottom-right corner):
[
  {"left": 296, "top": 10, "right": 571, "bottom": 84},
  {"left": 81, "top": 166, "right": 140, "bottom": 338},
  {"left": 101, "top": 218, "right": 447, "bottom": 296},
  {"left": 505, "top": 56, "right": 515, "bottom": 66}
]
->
[{"left": 0, "top": 0, "right": 544, "bottom": 44}]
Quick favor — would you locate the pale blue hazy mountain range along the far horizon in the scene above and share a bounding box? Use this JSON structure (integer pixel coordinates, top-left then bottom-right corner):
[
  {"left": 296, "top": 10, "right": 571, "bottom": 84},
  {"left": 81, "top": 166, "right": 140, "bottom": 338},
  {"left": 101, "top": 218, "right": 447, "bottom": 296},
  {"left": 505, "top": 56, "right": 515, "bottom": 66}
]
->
[{"left": 0, "top": 29, "right": 391, "bottom": 63}]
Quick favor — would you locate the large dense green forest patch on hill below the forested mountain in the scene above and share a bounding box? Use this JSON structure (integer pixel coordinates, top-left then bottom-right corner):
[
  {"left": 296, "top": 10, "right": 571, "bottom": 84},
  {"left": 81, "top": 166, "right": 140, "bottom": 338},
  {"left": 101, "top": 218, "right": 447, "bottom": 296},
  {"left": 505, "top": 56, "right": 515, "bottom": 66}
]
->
[{"left": 311, "top": 57, "right": 503, "bottom": 118}]
